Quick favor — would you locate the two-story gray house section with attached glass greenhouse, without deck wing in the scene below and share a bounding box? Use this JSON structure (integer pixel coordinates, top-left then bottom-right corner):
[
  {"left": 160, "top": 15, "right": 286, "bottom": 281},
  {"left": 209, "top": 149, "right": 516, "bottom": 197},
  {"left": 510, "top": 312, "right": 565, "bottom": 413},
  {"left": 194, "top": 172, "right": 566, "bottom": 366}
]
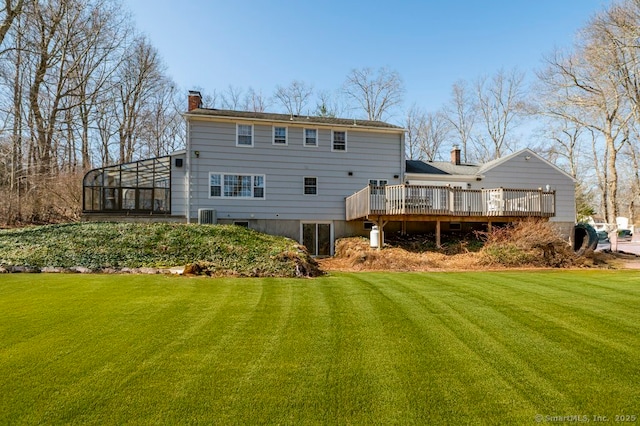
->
[{"left": 83, "top": 92, "right": 404, "bottom": 255}]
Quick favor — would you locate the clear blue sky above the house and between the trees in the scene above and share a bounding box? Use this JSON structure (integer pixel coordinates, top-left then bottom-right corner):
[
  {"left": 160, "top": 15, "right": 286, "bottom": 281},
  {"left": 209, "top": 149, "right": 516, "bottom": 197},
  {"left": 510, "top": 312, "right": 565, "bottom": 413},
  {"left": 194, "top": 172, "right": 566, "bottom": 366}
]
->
[{"left": 124, "top": 0, "right": 611, "bottom": 121}]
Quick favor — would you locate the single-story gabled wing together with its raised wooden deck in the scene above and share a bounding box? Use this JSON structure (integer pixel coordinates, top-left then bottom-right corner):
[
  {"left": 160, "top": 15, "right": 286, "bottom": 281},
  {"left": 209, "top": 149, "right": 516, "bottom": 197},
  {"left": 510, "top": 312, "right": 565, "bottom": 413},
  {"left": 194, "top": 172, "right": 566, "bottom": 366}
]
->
[{"left": 347, "top": 147, "right": 576, "bottom": 245}]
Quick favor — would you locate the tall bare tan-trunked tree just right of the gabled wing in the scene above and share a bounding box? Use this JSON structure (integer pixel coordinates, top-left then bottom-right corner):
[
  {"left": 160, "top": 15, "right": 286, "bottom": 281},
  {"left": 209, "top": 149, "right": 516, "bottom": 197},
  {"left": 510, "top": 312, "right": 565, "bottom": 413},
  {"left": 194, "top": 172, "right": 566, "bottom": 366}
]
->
[{"left": 539, "top": 3, "right": 638, "bottom": 223}]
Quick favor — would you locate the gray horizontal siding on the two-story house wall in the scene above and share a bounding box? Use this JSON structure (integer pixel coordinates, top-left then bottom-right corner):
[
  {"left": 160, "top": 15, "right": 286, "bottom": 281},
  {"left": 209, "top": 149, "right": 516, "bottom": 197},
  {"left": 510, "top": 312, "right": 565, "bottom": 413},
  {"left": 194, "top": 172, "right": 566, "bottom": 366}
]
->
[{"left": 188, "top": 120, "right": 404, "bottom": 220}]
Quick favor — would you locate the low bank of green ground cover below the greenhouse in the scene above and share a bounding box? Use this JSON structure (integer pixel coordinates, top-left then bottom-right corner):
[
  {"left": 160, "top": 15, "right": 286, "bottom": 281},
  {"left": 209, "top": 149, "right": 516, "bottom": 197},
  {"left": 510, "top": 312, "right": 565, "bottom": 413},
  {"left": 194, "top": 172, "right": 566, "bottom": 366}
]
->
[{"left": 0, "top": 223, "right": 310, "bottom": 276}]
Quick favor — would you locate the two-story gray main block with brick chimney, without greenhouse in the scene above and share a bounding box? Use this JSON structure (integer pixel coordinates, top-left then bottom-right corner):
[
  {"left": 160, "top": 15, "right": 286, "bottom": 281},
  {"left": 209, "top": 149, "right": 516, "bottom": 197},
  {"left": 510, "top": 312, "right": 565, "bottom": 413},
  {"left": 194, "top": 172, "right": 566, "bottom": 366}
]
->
[{"left": 184, "top": 93, "right": 404, "bottom": 255}]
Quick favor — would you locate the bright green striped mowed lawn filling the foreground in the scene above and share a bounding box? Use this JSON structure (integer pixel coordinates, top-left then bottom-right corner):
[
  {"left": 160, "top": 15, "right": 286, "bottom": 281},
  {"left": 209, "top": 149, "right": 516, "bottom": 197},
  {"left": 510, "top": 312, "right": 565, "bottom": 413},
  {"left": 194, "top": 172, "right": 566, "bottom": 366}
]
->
[{"left": 0, "top": 271, "right": 640, "bottom": 424}]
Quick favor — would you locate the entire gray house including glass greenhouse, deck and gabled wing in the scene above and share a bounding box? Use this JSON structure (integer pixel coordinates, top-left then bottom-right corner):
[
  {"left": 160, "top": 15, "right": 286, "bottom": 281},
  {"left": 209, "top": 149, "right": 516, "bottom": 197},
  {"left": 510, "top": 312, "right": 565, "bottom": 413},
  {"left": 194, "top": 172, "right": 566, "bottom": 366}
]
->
[{"left": 83, "top": 92, "right": 575, "bottom": 256}]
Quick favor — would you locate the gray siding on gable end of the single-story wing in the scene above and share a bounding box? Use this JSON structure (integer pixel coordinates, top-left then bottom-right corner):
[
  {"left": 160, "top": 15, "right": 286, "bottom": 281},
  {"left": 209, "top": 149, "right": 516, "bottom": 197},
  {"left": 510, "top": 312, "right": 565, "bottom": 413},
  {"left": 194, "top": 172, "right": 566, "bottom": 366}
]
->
[{"left": 482, "top": 152, "right": 576, "bottom": 224}]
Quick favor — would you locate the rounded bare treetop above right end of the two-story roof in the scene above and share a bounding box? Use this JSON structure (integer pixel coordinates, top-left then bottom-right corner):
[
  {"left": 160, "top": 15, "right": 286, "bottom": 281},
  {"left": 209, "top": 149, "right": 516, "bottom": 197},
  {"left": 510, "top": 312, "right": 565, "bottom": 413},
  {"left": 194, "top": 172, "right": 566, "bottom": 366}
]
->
[{"left": 342, "top": 68, "right": 405, "bottom": 121}]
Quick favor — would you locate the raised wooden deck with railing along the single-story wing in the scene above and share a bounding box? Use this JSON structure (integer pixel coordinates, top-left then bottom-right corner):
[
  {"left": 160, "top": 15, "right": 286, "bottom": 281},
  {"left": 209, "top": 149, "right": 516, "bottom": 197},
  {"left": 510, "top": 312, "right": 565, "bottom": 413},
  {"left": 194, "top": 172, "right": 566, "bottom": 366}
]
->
[{"left": 346, "top": 185, "right": 556, "bottom": 221}]
